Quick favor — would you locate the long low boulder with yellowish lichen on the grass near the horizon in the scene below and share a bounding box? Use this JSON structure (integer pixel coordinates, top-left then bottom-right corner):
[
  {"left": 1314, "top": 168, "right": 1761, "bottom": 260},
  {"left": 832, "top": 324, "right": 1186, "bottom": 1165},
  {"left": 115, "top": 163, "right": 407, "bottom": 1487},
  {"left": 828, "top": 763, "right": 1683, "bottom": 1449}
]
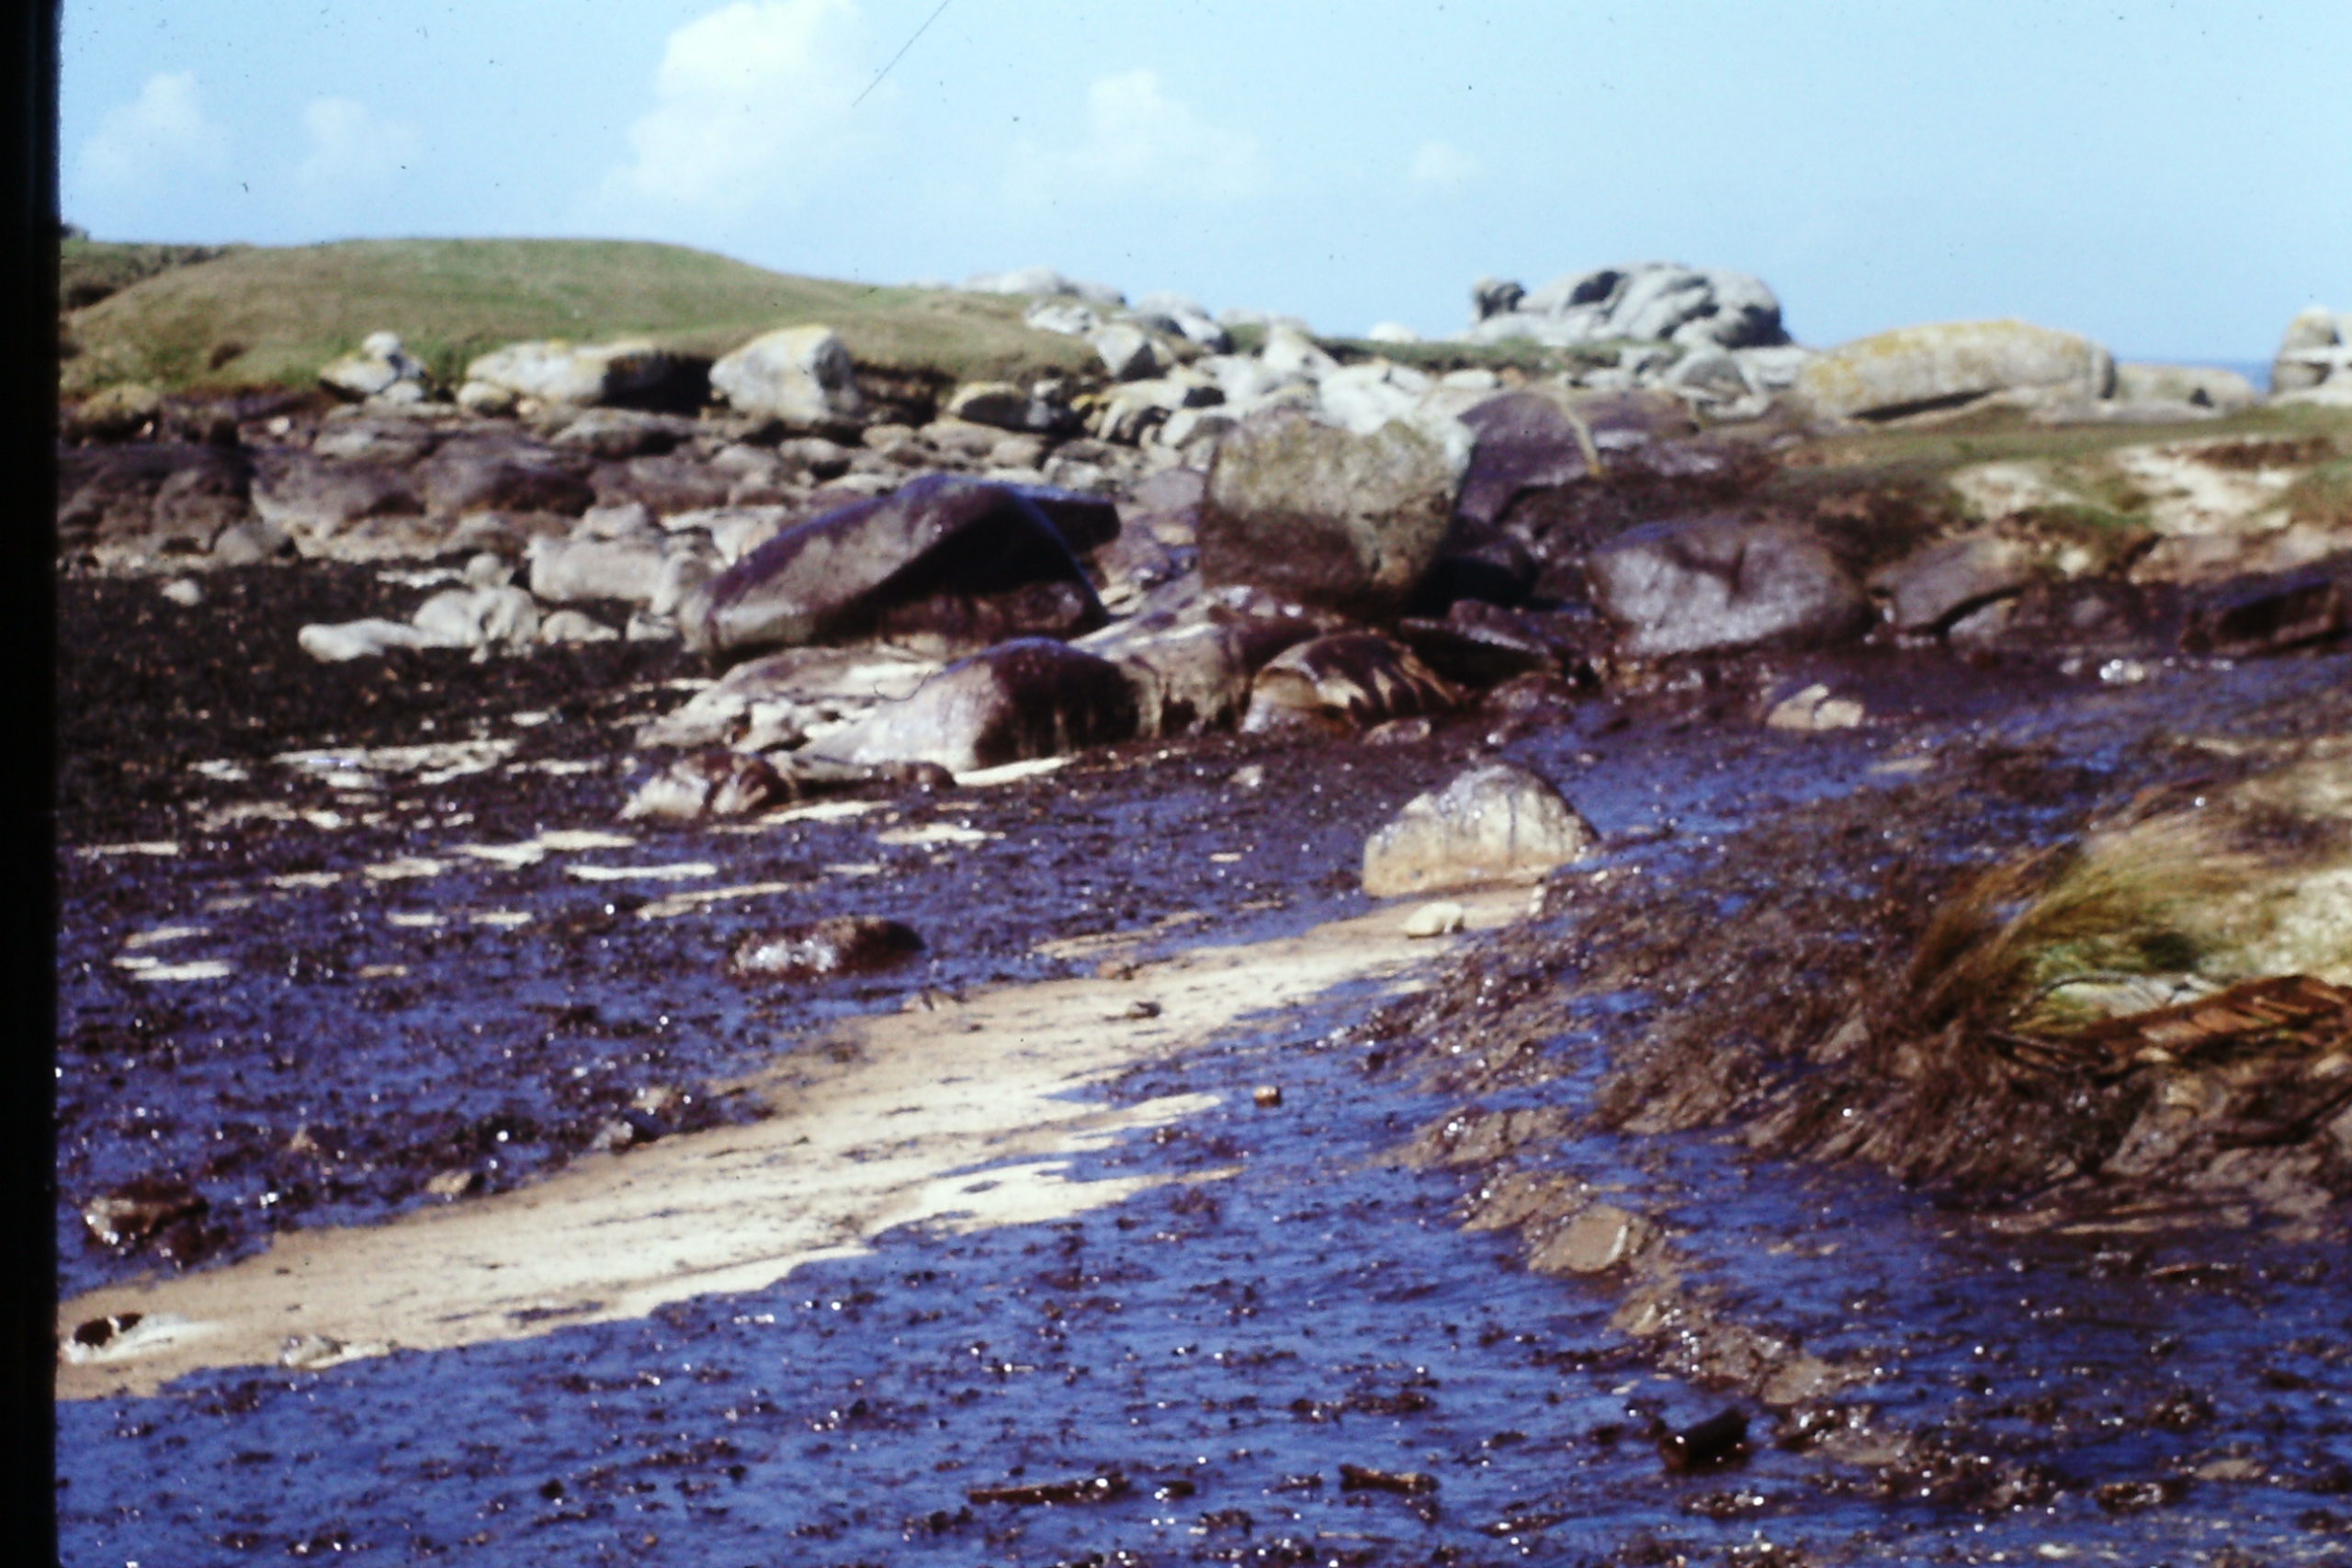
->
[{"left": 1797, "top": 320, "right": 2114, "bottom": 419}]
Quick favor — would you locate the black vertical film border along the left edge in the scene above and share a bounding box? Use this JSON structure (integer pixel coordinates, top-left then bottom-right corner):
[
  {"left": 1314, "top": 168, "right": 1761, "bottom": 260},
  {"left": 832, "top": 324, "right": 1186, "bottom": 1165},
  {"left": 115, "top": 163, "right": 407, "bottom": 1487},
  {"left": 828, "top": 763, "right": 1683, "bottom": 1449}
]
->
[{"left": 0, "top": 0, "right": 62, "bottom": 1561}]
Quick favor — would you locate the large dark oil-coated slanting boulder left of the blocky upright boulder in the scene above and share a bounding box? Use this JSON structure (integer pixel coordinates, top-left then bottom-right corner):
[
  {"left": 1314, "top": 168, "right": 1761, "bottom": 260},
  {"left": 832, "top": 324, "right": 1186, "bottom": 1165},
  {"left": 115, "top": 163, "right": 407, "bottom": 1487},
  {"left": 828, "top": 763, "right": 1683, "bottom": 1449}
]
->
[{"left": 680, "top": 475, "right": 1117, "bottom": 656}]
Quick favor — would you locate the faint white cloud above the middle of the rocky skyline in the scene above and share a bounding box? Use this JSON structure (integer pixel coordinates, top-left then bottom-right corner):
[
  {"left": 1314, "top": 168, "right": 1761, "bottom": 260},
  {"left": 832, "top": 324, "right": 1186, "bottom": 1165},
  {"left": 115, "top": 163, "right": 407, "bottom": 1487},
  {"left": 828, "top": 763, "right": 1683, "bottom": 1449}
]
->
[{"left": 1009, "top": 71, "right": 1268, "bottom": 202}]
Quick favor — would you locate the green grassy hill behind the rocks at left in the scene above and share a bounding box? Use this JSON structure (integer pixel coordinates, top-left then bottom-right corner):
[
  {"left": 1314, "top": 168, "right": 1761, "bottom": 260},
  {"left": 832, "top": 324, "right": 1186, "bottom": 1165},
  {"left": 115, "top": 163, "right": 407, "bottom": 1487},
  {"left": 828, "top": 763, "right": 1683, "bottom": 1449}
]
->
[{"left": 62, "top": 240, "right": 1093, "bottom": 398}]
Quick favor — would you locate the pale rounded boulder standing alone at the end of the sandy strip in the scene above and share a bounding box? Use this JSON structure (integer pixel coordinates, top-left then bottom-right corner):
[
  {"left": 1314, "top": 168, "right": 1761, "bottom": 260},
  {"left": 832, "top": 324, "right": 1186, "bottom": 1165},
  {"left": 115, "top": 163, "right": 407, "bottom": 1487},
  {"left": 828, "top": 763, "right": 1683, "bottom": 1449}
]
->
[{"left": 1364, "top": 761, "right": 1597, "bottom": 898}]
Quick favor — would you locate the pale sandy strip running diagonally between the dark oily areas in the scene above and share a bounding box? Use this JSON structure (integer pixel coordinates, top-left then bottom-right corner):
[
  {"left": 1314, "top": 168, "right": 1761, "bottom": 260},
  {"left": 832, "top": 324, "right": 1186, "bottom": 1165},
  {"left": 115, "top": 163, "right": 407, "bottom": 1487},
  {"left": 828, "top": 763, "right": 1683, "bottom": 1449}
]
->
[{"left": 56, "top": 888, "right": 1526, "bottom": 1399}]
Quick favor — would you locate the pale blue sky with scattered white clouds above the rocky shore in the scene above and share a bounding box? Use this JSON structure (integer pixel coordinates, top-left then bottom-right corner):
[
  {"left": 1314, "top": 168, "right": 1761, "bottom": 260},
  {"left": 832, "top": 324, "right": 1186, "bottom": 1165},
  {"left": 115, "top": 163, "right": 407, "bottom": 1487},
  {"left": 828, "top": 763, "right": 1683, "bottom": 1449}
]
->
[{"left": 59, "top": 0, "right": 2352, "bottom": 360}]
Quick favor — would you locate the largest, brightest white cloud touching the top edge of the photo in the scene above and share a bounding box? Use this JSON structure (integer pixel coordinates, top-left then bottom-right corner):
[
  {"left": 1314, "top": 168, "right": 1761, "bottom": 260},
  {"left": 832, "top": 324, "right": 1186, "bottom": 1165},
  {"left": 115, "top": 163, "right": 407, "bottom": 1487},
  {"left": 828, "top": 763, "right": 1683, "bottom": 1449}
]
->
[{"left": 602, "top": 0, "right": 887, "bottom": 216}]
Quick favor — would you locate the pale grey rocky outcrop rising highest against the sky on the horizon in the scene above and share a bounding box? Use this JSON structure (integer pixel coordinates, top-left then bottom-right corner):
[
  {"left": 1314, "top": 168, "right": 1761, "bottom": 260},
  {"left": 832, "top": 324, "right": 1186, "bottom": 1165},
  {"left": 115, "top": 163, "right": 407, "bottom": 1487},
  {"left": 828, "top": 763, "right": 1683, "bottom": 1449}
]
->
[{"left": 1463, "top": 261, "right": 1788, "bottom": 348}]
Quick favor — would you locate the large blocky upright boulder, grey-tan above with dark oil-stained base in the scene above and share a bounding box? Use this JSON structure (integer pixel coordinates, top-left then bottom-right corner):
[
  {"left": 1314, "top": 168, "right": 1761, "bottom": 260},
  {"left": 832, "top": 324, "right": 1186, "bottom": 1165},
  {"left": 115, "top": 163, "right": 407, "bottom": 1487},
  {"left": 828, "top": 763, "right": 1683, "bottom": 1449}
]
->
[{"left": 1200, "top": 409, "right": 1456, "bottom": 621}]
